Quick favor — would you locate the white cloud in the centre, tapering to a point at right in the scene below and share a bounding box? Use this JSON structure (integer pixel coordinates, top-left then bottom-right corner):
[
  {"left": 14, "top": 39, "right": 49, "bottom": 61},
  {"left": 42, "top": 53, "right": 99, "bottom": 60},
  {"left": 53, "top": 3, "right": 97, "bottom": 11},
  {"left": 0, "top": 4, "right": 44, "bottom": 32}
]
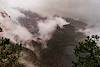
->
[{"left": 38, "top": 17, "right": 69, "bottom": 40}]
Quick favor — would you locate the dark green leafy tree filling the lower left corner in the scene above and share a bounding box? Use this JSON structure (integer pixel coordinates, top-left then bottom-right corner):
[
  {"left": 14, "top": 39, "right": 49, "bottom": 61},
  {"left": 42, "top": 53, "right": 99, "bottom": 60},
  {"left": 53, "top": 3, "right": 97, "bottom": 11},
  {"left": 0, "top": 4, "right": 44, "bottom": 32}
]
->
[{"left": 0, "top": 38, "right": 22, "bottom": 67}]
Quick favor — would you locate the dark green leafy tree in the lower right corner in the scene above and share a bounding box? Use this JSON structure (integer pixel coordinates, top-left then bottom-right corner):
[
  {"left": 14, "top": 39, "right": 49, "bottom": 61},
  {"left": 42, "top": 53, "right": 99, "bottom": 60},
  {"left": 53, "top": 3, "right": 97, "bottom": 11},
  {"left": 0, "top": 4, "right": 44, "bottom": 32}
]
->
[{"left": 72, "top": 35, "right": 100, "bottom": 67}]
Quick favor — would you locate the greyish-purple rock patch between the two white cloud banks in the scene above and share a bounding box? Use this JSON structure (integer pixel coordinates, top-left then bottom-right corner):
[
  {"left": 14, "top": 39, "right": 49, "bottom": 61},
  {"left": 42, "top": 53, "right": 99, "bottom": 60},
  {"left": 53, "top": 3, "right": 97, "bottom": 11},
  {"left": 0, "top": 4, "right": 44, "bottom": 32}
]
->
[{"left": 18, "top": 10, "right": 46, "bottom": 34}]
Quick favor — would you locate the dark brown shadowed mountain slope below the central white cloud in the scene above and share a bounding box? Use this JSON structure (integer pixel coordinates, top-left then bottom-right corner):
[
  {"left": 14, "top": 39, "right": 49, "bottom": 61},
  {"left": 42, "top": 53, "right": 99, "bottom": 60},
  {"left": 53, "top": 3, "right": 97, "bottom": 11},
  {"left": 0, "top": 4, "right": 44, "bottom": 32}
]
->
[{"left": 41, "top": 24, "right": 85, "bottom": 67}]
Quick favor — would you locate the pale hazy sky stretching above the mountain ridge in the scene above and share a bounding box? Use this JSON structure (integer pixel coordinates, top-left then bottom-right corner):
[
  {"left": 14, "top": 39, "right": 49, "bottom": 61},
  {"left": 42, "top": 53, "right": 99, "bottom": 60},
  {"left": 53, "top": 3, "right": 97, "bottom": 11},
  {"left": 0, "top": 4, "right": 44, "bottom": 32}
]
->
[{"left": 0, "top": 0, "right": 100, "bottom": 33}]
